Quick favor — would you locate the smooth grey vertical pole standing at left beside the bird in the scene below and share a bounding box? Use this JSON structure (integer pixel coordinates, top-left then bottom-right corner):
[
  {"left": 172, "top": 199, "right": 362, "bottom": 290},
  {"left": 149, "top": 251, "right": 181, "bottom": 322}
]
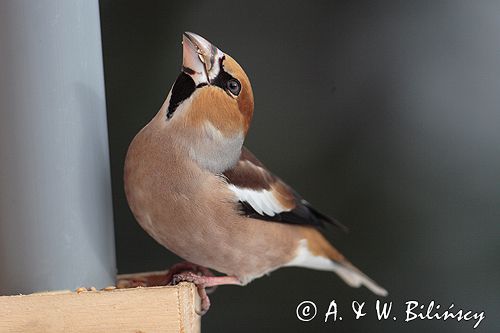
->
[{"left": 0, "top": 0, "right": 115, "bottom": 294}]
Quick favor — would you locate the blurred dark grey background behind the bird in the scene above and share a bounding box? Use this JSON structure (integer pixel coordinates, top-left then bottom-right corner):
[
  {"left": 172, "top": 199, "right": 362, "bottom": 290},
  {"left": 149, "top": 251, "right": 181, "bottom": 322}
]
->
[{"left": 101, "top": 0, "right": 500, "bottom": 332}]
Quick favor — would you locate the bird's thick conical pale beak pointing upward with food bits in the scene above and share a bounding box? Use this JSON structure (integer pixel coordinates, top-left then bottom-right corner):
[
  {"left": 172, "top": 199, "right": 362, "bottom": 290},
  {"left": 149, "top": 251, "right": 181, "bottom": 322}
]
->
[{"left": 182, "top": 32, "right": 224, "bottom": 84}]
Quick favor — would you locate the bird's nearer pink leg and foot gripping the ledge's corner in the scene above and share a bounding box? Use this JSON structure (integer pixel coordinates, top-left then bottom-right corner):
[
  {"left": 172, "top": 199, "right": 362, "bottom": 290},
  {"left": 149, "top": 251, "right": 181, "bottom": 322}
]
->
[{"left": 172, "top": 272, "right": 241, "bottom": 315}]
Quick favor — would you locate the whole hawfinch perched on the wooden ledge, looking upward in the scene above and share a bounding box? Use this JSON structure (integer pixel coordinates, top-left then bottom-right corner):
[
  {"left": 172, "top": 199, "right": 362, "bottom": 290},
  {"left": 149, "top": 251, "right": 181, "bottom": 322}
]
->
[{"left": 124, "top": 32, "right": 387, "bottom": 314}]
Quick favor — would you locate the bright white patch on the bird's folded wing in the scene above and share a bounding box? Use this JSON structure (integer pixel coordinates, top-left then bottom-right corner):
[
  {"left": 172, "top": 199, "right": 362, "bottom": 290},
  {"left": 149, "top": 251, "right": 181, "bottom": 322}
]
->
[{"left": 228, "top": 184, "right": 290, "bottom": 216}]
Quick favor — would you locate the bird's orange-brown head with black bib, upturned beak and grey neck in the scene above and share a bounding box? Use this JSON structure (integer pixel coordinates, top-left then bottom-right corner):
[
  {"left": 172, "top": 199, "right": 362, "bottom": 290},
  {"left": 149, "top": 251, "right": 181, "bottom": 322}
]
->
[{"left": 162, "top": 32, "right": 254, "bottom": 172}]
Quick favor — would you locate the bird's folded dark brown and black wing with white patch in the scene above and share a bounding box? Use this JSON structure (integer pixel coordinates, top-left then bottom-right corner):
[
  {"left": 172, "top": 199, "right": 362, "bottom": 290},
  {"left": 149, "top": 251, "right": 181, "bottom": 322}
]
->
[{"left": 224, "top": 147, "right": 346, "bottom": 230}]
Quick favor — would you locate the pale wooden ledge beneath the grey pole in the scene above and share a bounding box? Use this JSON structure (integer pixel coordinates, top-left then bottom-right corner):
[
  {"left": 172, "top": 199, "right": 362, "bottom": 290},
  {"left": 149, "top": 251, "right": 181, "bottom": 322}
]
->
[{"left": 0, "top": 283, "right": 200, "bottom": 333}]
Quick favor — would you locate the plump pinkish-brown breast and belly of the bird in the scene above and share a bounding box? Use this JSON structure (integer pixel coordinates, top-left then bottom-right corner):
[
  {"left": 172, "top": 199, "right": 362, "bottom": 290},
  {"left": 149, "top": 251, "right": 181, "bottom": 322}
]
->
[{"left": 124, "top": 118, "right": 303, "bottom": 282}]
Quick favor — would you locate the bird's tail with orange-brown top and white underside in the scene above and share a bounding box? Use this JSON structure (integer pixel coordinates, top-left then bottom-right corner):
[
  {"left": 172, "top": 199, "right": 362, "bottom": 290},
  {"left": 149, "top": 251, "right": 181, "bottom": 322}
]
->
[{"left": 288, "top": 228, "right": 388, "bottom": 296}]
